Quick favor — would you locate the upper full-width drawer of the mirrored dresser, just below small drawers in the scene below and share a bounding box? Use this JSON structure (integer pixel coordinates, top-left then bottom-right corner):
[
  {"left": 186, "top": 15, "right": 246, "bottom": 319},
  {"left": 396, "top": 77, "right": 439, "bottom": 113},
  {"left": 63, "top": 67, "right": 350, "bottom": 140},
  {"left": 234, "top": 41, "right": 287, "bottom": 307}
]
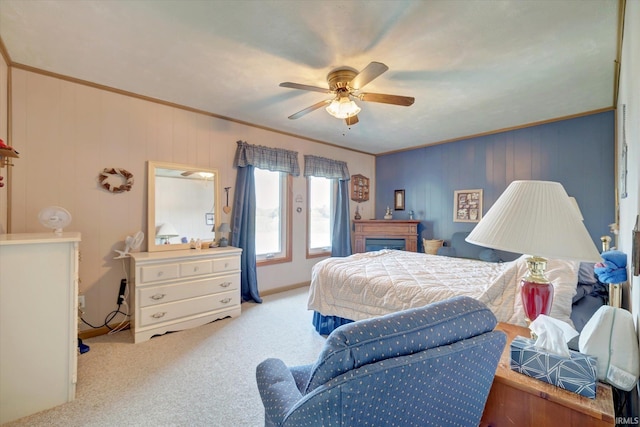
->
[{"left": 138, "top": 274, "right": 240, "bottom": 307}]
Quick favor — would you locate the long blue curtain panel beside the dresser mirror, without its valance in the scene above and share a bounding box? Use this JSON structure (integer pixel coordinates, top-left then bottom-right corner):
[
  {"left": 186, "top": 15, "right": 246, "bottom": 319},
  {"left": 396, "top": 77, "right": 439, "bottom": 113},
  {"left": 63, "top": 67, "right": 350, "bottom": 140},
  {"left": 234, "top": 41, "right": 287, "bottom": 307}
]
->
[{"left": 231, "top": 165, "right": 262, "bottom": 303}]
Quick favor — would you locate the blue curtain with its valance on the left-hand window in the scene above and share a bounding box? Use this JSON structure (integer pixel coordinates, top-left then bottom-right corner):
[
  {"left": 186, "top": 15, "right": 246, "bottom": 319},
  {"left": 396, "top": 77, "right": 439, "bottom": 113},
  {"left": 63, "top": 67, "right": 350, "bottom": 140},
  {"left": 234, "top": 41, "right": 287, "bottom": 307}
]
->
[{"left": 231, "top": 141, "right": 300, "bottom": 303}]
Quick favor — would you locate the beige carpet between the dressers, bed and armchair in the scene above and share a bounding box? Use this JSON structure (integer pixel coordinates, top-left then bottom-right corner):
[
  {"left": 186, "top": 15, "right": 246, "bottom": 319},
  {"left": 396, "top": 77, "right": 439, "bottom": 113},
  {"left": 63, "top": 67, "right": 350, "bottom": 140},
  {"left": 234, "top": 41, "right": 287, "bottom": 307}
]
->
[{"left": 6, "top": 287, "right": 324, "bottom": 427}]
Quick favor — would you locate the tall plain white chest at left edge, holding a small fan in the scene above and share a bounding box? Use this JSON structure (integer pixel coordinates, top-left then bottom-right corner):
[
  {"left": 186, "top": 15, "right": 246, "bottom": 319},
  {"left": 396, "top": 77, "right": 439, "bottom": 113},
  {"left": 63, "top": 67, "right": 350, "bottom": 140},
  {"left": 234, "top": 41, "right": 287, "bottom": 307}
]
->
[{"left": 0, "top": 232, "right": 80, "bottom": 424}]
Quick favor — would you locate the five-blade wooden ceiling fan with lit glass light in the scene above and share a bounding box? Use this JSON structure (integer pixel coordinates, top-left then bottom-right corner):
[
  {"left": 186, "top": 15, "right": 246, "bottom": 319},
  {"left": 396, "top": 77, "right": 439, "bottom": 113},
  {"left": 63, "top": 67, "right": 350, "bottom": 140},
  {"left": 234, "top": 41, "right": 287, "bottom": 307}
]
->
[{"left": 280, "top": 62, "right": 415, "bottom": 125}]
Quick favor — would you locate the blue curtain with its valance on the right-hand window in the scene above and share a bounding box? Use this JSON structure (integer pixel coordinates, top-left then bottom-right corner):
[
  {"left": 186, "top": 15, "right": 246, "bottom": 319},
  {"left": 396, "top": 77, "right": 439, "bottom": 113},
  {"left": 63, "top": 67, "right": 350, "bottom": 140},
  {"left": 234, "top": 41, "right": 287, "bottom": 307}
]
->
[{"left": 304, "top": 155, "right": 351, "bottom": 257}]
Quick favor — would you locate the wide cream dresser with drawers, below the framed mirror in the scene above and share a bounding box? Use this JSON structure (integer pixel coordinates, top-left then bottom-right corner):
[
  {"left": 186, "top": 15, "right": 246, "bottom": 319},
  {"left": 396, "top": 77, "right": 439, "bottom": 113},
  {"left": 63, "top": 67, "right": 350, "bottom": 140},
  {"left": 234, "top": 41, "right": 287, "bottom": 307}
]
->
[{"left": 130, "top": 247, "right": 242, "bottom": 343}]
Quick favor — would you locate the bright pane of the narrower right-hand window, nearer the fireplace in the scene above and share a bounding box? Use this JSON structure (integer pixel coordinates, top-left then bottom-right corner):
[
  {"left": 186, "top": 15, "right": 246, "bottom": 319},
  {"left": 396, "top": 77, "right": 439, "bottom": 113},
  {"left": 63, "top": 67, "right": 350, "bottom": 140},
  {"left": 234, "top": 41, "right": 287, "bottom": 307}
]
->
[{"left": 307, "top": 176, "right": 335, "bottom": 256}]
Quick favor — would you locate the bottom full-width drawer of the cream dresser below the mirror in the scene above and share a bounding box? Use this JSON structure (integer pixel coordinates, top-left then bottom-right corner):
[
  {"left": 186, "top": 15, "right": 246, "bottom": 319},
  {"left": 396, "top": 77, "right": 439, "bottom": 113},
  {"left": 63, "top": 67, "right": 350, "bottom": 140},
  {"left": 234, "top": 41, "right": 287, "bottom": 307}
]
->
[{"left": 139, "top": 291, "right": 240, "bottom": 326}]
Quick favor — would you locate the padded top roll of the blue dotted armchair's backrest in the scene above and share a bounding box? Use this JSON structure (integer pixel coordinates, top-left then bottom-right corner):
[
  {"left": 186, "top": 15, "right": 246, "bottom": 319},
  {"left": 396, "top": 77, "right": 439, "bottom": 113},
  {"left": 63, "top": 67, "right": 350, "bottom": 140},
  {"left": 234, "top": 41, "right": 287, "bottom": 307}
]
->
[{"left": 303, "top": 296, "right": 497, "bottom": 394}]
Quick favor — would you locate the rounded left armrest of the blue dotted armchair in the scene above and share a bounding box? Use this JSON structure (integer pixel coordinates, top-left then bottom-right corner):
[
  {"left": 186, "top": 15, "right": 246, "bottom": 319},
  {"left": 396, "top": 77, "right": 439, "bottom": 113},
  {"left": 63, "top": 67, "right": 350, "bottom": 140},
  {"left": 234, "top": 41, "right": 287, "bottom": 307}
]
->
[{"left": 256, "top": 359, "right": 302, "bottom": 424}]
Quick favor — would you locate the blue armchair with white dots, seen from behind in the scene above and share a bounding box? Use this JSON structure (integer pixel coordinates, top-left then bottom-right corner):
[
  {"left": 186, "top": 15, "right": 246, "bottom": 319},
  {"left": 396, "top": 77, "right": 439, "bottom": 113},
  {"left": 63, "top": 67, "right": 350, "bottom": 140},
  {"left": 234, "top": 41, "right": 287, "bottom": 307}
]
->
[{"left": 256, "top": 297, "right": 506, "bottom": 427}]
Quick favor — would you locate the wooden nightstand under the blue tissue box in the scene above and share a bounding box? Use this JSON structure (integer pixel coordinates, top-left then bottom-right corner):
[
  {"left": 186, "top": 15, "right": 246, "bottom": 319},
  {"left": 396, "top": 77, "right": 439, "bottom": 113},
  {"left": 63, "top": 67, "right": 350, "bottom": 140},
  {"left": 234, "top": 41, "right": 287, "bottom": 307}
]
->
[{"left": 480, "top": 323, "right": 615, "bottom": 427}]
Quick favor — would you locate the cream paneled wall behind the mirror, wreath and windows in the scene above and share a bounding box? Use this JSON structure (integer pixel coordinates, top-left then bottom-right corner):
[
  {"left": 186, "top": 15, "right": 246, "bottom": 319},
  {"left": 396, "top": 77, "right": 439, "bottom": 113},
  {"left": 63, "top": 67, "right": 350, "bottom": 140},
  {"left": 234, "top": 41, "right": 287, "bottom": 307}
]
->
[{"left": 9, "top": 69, "right": 375, "bottom": 332}]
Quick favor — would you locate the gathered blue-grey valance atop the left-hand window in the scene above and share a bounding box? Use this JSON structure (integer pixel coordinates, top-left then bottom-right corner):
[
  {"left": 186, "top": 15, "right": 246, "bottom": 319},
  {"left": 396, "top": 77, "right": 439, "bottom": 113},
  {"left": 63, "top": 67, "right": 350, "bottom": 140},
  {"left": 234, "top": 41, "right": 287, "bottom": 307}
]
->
[{"left": 233, "top": 141, "right": 300, "bottom": 176}]
